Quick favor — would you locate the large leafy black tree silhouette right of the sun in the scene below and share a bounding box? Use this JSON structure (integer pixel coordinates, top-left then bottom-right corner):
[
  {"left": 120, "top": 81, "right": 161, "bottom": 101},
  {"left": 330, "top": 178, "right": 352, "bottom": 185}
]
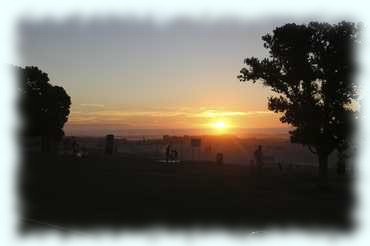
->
[{"left": 238, "top": 22, "right": 358, "bottom": 181}]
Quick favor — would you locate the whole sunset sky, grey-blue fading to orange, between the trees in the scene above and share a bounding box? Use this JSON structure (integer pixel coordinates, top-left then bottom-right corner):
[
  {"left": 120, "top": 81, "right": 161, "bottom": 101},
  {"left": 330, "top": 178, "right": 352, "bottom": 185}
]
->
[{"left": 19, "top": 18, "right": 298, "bottom": 135}]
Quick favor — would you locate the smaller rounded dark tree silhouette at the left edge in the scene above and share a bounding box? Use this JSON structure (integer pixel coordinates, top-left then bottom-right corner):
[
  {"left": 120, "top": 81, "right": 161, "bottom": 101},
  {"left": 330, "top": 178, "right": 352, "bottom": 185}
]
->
[{"left": 16, "top": 66, "right": 71, "bottom": 152}]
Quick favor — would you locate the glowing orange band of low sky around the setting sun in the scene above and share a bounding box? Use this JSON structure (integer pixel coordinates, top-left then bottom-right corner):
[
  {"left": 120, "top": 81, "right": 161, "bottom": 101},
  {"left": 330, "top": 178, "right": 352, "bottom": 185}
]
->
[{"left": 65, "top": 105, "right": 286, "bottom": 134}]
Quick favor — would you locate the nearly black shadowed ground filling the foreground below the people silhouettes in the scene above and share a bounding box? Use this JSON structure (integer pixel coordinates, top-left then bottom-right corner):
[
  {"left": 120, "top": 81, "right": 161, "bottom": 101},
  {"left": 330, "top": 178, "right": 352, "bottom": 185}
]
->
[{"left": 20, "top": 155, "right": 353, "bottom": 231}]
